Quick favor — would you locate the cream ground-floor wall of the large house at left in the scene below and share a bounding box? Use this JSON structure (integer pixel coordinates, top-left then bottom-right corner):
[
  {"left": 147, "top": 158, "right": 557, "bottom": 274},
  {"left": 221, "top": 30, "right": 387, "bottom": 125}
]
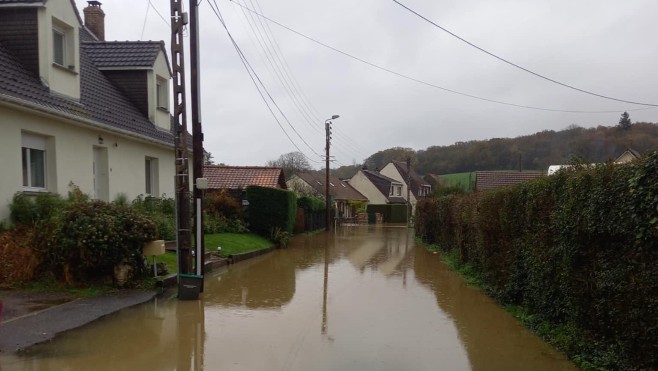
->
[{"left": 0, "top": 106, "right": 175, "bottom": 220}]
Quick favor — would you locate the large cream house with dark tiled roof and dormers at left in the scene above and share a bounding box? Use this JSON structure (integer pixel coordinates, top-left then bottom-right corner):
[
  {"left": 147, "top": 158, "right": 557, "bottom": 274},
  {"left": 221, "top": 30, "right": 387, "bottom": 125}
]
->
[{"left": 0, "top": 0, "right": 175, "bottom": 220}]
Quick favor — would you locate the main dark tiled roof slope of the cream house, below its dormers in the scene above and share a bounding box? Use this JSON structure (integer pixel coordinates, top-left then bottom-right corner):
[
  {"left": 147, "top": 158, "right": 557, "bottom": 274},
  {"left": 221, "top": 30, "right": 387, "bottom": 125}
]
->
[{"left": 0, "top": 23, "right": 174, "bottom": 145}]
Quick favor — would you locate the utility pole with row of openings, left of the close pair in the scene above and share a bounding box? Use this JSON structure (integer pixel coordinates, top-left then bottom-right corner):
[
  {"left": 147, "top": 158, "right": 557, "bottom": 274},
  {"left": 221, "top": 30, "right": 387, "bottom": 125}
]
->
[{"left": 171, "top": 0, "right": 192, "bottom": 276}]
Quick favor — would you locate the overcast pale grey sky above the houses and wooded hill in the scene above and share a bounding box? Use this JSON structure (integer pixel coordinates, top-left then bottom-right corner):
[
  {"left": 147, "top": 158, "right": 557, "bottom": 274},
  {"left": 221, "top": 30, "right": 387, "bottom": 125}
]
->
[{"left": 76, "top": 0, "right": 658, "bottom": 168}]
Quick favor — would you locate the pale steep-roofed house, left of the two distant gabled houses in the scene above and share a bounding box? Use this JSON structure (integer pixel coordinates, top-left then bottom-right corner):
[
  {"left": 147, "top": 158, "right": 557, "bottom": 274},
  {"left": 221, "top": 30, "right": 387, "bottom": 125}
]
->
[{"left": 349, "top": 169, "right": 407, "bottom": 205}]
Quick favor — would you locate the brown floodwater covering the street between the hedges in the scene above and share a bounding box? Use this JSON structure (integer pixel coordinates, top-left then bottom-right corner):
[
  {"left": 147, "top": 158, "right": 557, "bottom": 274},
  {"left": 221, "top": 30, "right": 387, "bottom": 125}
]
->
[{"left": 0, "top": 226, "right": 575, "bottom": 371}]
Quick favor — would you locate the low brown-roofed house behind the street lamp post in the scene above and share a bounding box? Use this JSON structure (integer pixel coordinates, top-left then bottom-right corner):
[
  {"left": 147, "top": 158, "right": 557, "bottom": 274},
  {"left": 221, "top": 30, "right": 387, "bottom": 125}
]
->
[{"left": 288, "top": 173, "right": 368, "bottom": 218}]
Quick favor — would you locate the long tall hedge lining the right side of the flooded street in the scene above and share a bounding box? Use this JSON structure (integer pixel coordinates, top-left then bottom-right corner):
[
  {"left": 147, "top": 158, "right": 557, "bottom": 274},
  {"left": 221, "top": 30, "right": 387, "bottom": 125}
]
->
[{"left": 416, "top": 153, "right": 658, "bottom": 369}]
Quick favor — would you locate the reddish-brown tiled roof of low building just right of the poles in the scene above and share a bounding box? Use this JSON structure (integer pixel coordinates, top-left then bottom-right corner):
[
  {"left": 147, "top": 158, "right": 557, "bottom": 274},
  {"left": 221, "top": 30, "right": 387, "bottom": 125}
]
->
[{"left": 203, "top": 165, "right": 288, "bottom": 189}]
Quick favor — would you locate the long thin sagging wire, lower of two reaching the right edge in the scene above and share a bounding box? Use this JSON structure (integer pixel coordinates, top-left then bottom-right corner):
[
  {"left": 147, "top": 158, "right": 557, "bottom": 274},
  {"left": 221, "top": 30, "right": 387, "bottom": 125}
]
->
[{"left": 230, "top": 0, "right": 653, "bottom": 114}]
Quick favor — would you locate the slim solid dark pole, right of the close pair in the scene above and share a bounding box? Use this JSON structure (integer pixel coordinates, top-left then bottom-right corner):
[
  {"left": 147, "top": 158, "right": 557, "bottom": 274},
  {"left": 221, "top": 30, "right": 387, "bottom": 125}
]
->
[{"left": 189, "top": 0, "right": 202, "bottom": 292}]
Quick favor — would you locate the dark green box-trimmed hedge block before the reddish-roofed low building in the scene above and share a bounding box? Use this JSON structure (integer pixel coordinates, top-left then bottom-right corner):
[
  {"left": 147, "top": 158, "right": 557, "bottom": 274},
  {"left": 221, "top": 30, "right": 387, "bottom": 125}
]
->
[{"left": 247, "top": 186, "right": 297, "bottom": 237}]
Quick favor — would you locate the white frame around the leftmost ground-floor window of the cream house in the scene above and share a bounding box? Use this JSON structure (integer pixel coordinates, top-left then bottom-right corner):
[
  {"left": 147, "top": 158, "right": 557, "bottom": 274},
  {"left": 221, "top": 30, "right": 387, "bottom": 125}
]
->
[{"left": 21, "top": 133, "right": 48, "bottom": 192}]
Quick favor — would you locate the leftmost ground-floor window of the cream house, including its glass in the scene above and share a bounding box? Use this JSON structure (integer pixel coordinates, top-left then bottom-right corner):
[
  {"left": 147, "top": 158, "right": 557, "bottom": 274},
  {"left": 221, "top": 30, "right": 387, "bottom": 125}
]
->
[{"left": 21, "top": 134, "right": 46, "bottom": 191}]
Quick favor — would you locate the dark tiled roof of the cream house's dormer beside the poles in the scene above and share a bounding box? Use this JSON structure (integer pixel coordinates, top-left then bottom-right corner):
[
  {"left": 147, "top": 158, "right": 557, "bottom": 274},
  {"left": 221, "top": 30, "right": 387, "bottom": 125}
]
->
[{"left": 80, "top": 40, "right": 171, "bottom": 74}]
